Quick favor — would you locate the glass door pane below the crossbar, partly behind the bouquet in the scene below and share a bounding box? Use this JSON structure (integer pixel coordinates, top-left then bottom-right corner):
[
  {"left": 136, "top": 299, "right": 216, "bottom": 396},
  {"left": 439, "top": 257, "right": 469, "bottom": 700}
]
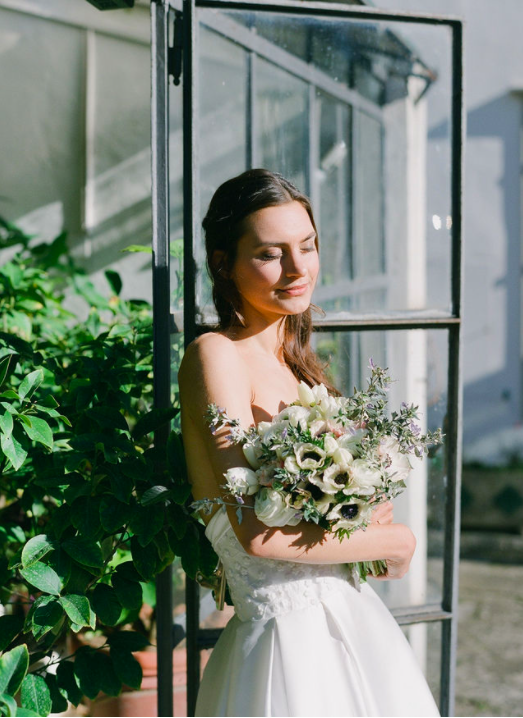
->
[{"left": 314, "top": 329, "right": 448, "bottom": 608}]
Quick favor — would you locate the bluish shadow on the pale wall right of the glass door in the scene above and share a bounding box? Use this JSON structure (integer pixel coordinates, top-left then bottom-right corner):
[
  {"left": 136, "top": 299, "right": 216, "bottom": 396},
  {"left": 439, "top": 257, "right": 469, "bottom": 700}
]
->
[{"left": 429, "top": 94, "right": 522, "bottom": 443}]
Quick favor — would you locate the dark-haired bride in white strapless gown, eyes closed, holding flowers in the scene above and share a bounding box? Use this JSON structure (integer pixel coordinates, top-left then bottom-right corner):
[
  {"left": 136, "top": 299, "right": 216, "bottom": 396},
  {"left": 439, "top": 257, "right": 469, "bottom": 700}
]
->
[{"left": 179, "top": 169, "right": 438, "bottom": 716}]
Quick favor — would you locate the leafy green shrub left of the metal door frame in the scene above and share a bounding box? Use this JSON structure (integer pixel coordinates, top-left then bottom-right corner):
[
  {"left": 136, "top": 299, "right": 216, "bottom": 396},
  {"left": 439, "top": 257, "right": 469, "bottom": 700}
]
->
[{"left": 0, "top": 219, "right": 217, "bottom": 716}]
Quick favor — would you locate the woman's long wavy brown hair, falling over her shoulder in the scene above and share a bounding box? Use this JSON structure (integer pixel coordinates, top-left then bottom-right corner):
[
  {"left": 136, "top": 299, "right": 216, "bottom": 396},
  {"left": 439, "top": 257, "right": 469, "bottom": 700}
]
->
[{"left": 202, "top": 169, "right": 339, "bottom": 394}]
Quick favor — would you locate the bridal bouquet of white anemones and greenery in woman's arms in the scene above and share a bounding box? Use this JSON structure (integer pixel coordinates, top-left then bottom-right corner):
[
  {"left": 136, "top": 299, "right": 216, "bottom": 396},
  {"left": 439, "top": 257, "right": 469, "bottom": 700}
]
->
[{"left": 193, "top": 360, "right": 442, "bottom": 580}]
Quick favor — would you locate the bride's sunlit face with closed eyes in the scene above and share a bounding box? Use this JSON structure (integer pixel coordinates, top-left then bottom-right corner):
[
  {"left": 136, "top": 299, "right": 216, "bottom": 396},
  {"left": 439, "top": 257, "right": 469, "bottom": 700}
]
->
[{"left": 231, "top": 201, "right": 319, "bottom": 320}]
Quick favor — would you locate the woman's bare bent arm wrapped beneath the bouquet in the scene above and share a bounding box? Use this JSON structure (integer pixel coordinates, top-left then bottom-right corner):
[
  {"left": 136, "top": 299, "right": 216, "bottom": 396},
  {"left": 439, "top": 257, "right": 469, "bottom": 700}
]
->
[{"left": 179, "top": 334, "right": 415, "bottom": 578}]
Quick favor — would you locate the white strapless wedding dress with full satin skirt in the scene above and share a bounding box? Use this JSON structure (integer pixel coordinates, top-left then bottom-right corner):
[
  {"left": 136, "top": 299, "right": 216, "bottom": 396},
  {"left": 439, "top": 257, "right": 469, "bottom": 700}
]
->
[{"left": 196, "top": 510, "right": 439, "bottom": 717}]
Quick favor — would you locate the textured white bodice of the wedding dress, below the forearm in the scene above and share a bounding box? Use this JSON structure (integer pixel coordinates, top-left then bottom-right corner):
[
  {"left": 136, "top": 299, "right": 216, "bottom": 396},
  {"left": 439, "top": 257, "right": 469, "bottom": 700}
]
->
[{"left": 205, "top": 510, "right": 359, "bottom": 621}]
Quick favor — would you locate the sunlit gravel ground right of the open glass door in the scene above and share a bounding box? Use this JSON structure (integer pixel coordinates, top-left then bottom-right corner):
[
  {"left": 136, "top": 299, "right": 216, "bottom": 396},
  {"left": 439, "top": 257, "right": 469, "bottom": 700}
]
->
[{"left": 456, "top": 561, "right": 523, "bottom": 716}]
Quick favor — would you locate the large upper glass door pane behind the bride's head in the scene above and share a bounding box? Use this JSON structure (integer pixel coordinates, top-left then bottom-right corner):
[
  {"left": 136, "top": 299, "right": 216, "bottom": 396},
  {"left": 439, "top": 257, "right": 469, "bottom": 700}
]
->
[{"left": 194, "top": 8, "right": 452, "bottom": 318}]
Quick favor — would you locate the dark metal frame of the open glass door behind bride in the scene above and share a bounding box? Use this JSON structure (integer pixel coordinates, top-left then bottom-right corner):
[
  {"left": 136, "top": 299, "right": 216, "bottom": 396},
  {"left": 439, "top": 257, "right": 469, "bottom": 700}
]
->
[{"left": 151, "top": 0, "right": 464, "bottom": 716}]
